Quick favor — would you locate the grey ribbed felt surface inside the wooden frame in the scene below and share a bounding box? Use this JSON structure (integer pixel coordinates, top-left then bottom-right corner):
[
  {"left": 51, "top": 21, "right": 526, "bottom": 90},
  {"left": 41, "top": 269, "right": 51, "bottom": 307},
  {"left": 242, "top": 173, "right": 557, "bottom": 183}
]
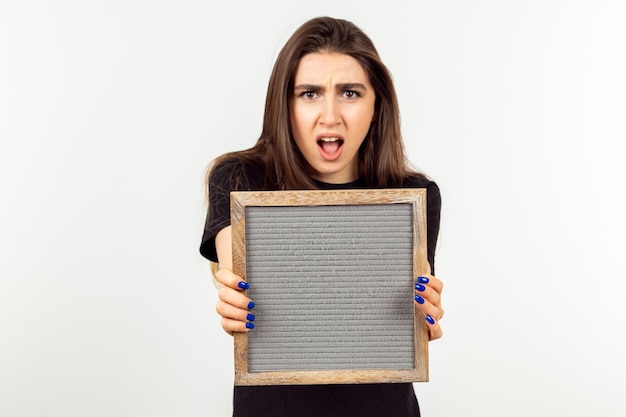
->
[{"left": 246, "top": 204, "right": 415, "bottom": 372}]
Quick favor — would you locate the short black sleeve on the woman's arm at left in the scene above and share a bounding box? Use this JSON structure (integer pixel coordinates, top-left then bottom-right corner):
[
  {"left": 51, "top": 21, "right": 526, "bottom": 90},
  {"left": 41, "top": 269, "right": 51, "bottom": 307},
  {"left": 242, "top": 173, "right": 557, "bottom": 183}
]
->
[{"left": 200, "top": 162, "right": 237, "bottom": 262}]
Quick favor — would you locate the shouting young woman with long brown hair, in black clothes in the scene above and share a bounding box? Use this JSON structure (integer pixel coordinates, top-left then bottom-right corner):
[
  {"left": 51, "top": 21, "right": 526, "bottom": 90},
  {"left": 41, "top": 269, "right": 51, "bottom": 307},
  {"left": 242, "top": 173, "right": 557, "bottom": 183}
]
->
[{"left": 200, "top": 17, "right": 443, "bottom": 417}]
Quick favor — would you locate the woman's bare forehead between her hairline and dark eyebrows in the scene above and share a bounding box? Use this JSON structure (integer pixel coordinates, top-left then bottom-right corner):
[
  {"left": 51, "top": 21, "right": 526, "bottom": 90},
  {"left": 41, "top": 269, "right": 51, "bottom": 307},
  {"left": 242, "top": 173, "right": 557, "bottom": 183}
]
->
[{"left": 294, "top": 52, "right": 369, "bottom": 84}]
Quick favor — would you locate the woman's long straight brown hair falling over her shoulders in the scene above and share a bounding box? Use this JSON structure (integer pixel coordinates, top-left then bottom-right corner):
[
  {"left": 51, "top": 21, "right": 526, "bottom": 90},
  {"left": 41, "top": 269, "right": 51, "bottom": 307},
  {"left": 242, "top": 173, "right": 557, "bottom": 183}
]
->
[{"left": 207, "top": 17, "right": 420, "bottom": 189}]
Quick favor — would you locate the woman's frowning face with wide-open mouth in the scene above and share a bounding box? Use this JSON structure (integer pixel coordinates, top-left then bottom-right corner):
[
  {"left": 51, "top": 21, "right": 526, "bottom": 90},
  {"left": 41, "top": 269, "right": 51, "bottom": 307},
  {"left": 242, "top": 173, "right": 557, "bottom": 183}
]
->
[{"left": 289, "top": 52, "right": 376, "bottom": 184}]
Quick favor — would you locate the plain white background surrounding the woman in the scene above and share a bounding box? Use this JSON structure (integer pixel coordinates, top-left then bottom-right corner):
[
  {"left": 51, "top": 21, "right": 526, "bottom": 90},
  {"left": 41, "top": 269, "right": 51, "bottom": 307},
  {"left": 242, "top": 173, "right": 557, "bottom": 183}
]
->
[{"left": 0, "top": 0, "right": 626, "bottom": 417}]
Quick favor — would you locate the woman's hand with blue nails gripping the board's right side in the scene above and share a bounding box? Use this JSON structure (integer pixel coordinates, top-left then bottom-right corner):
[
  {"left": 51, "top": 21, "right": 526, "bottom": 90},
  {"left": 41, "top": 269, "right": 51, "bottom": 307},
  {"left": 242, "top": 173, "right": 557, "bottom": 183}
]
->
[{"left": 415, "top": 274, "right": 443, "bottom": 340}]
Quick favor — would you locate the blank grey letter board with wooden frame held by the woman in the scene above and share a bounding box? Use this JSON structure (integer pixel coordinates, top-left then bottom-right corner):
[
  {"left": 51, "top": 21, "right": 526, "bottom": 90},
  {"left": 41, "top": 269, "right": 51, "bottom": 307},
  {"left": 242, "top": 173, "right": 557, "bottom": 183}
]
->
[{"left": 231, "top": 189, "right": 429, "bottom": 385}]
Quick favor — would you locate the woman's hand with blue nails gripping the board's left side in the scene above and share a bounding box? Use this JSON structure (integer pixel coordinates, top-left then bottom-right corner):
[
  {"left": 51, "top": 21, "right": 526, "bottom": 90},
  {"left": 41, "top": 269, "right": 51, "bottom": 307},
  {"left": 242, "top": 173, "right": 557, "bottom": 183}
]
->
[{"left": 215, "top": 269, "right": 254, "bottom": 336}]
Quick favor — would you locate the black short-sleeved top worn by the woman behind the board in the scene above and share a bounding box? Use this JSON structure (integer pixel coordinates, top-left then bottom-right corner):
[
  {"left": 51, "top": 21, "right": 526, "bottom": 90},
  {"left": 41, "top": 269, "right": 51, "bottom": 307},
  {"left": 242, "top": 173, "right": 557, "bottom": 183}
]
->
[{"left": 200, "top": 161, "right": 441, "bottom": 417}]
